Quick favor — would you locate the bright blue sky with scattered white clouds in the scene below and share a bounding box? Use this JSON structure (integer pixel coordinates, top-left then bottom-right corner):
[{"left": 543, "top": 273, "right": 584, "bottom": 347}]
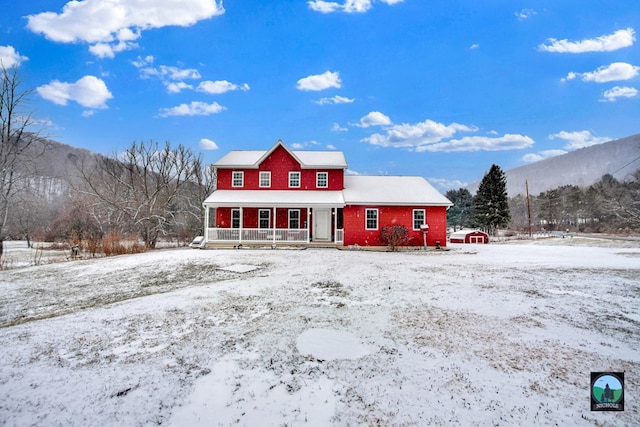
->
[{"left": 0, "top": 0, "right": 640, "bottom": 191}]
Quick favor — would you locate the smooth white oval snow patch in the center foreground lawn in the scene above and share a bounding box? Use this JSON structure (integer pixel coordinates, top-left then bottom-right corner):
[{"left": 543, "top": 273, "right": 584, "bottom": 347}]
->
[{"left": 296, "top": 328, "right": 370, "bottom": 360}]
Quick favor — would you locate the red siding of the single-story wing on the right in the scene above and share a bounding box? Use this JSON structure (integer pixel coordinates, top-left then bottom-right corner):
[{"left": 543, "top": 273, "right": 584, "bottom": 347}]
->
[{"left": 344, "top": 206, "right": 447, "bottom": 246}]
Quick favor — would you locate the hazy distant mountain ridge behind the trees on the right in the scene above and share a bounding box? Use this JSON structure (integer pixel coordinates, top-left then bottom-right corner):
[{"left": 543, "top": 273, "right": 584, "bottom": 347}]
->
[{"left": 467, "top": 134, "right": 640, "bottom": 197}]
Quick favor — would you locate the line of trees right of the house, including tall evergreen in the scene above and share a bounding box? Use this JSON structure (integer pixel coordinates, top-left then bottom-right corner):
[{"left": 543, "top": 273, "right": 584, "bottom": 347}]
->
[{"left": 446, "top": 165, "right": 640, "bottom": 234}]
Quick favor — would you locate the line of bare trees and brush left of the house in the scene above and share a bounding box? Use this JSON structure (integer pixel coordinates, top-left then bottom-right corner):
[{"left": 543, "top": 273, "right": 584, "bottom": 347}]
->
[{"left": 0, "top": 65, "right": 215, "bottom": 261}]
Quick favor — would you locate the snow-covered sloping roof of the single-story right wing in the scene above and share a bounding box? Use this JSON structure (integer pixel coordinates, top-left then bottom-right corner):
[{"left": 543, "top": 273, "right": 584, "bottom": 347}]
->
[{"left": 344, "top": 175, "right": 453, "bottom": 206}]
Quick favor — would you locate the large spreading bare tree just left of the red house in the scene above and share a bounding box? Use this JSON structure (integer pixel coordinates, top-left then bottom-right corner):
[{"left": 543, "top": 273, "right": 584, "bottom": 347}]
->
[{"left": 81, "top": 141, "right": 204, "bottom": 248}]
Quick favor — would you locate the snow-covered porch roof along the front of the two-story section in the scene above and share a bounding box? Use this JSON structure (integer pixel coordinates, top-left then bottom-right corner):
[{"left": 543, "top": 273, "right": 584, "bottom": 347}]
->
[{"left": 204, "top": 190, "right": 344, "bottom": 207}]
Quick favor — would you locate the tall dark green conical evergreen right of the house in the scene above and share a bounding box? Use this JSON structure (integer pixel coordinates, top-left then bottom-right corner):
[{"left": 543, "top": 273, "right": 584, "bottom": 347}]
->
[{"left": 473, "top": 164, "right": 511, "bottom": 235}]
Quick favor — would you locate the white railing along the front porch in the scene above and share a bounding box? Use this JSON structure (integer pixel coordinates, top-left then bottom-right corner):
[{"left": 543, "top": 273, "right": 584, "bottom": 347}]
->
[{"left": 207, "top": 228, "right": 308, "bottom": 243}]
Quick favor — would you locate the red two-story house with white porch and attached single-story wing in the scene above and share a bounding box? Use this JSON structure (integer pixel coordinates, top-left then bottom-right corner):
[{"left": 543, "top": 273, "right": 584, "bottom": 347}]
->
[{"left": 202, "top": 141, "right": 452, "bottom": 246}]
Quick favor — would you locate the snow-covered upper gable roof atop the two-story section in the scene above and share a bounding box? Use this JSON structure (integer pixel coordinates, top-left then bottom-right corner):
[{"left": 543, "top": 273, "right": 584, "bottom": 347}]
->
[{"left": 213, "top": 140, "right": 347, "bottom": 169}]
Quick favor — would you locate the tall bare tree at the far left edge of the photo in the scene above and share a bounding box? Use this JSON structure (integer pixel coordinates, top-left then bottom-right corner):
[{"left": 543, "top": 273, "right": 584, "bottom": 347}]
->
[{"left": 0, "top": 63, "right": 46, "bottom": 262}]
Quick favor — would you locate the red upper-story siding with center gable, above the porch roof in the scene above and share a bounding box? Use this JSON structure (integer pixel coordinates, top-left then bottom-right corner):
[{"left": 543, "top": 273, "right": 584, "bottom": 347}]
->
[{"left": 218, "top": 147, "right": 344, "bottom": 191}]
